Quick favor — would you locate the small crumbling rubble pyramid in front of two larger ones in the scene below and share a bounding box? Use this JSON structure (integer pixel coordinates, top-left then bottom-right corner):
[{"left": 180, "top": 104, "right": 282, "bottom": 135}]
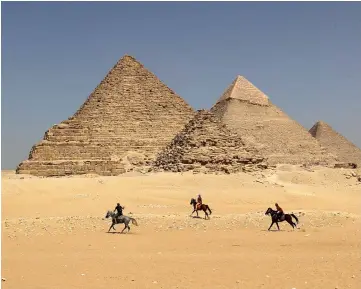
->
[{"left": 154, "top": 110, "right": 267, "bottom": 173}]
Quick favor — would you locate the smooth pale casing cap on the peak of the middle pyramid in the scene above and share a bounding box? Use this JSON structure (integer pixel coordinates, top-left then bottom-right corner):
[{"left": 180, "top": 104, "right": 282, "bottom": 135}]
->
[{"left": 217, "top": 75, "right": 269, "bottom": 106}]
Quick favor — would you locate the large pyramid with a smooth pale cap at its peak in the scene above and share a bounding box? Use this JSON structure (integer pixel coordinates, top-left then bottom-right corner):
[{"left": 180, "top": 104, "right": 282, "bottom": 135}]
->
[{"left": 211, "top": 76, "right": 335, "bottom": 165}]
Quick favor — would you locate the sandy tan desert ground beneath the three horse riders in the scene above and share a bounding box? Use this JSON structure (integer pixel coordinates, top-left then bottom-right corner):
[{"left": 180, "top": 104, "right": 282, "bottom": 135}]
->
[{"left": 1, "top": 166, "right": 361, "bottom": 289}]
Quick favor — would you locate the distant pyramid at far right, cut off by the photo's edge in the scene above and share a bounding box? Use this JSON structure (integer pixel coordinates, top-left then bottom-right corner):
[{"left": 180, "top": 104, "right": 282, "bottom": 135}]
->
[{"left": 309, "top": 121, "right": 361, "bottom": 166}]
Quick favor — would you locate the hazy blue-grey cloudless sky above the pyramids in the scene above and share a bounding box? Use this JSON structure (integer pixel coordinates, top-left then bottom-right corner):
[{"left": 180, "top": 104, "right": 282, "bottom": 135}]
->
[{"left": 1, "top": 2, "right": 361, "bottom": 169}]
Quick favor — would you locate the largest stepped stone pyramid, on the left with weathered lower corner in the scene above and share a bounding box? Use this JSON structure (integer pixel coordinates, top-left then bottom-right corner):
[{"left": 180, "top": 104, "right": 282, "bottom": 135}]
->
[{"left": 17, "top": 55, "right": 195, "bottom": 176}]
